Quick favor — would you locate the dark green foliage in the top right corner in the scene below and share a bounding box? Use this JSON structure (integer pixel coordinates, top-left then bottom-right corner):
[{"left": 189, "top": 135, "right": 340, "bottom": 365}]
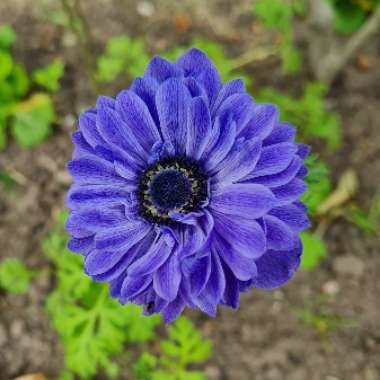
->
[{"left": 327, "top": 0, "right": 380, "bottom": 33}]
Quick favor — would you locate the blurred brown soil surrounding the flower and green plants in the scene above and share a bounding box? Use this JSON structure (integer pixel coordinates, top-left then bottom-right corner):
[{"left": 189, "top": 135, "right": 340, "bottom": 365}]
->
[{"left": 0, "top": 0, "right": 380, "bottom": 380}]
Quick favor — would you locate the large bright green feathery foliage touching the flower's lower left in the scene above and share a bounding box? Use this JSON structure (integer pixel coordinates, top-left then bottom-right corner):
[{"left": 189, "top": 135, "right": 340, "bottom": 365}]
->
[{"left": 42, "top": 209, "right": 160, "bottom": 379}]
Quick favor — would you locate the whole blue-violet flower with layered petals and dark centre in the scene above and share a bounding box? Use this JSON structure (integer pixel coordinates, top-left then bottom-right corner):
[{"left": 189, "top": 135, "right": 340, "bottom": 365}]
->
[{"left": 66, "top": 49, "right": 309, "bottom": 322}]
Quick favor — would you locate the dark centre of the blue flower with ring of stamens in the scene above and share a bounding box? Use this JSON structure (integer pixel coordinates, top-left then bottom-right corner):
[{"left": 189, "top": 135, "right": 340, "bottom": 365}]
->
[{"left": 139, "top": 157, "right": 207, "bottom": 225}]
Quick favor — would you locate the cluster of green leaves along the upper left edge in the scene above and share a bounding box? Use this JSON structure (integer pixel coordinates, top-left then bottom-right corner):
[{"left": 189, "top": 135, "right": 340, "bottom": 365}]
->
[{"left": 0, "top": 25, "right": 62, "bottom": 150}]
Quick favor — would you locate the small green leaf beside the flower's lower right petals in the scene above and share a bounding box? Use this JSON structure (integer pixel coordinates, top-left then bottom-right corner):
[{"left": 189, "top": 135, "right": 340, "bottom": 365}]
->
[{"left": 301, "top": 231, "right": 327, "bottom": 270}]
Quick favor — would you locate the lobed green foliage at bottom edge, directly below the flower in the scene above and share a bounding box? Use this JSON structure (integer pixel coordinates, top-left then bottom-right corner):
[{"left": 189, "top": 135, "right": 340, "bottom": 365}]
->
[{"left": 133, "top": 317, "right": 212, "bottom": 380}]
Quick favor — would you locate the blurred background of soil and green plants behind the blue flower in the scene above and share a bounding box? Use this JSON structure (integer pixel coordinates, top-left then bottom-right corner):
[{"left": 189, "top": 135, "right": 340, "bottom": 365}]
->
[{"left": 0, "top": 0, "right": 380, "bottom": 380}]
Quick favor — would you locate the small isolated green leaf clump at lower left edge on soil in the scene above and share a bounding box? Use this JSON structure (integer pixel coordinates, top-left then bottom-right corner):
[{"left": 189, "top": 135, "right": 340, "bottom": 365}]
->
[{"left": 0, "top": 258, "right": 36, "bottom": 294}]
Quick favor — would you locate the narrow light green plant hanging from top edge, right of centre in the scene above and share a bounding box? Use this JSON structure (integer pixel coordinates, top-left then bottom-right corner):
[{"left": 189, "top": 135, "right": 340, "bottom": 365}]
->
[{"left": 253, "top": 0, "right": 305, "bottom": 74}]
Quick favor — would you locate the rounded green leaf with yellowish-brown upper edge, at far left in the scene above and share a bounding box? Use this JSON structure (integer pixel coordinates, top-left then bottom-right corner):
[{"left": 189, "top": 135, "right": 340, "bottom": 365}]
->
[{"left": 12, "top": 94, "right": 56, "bottom": 148}]
